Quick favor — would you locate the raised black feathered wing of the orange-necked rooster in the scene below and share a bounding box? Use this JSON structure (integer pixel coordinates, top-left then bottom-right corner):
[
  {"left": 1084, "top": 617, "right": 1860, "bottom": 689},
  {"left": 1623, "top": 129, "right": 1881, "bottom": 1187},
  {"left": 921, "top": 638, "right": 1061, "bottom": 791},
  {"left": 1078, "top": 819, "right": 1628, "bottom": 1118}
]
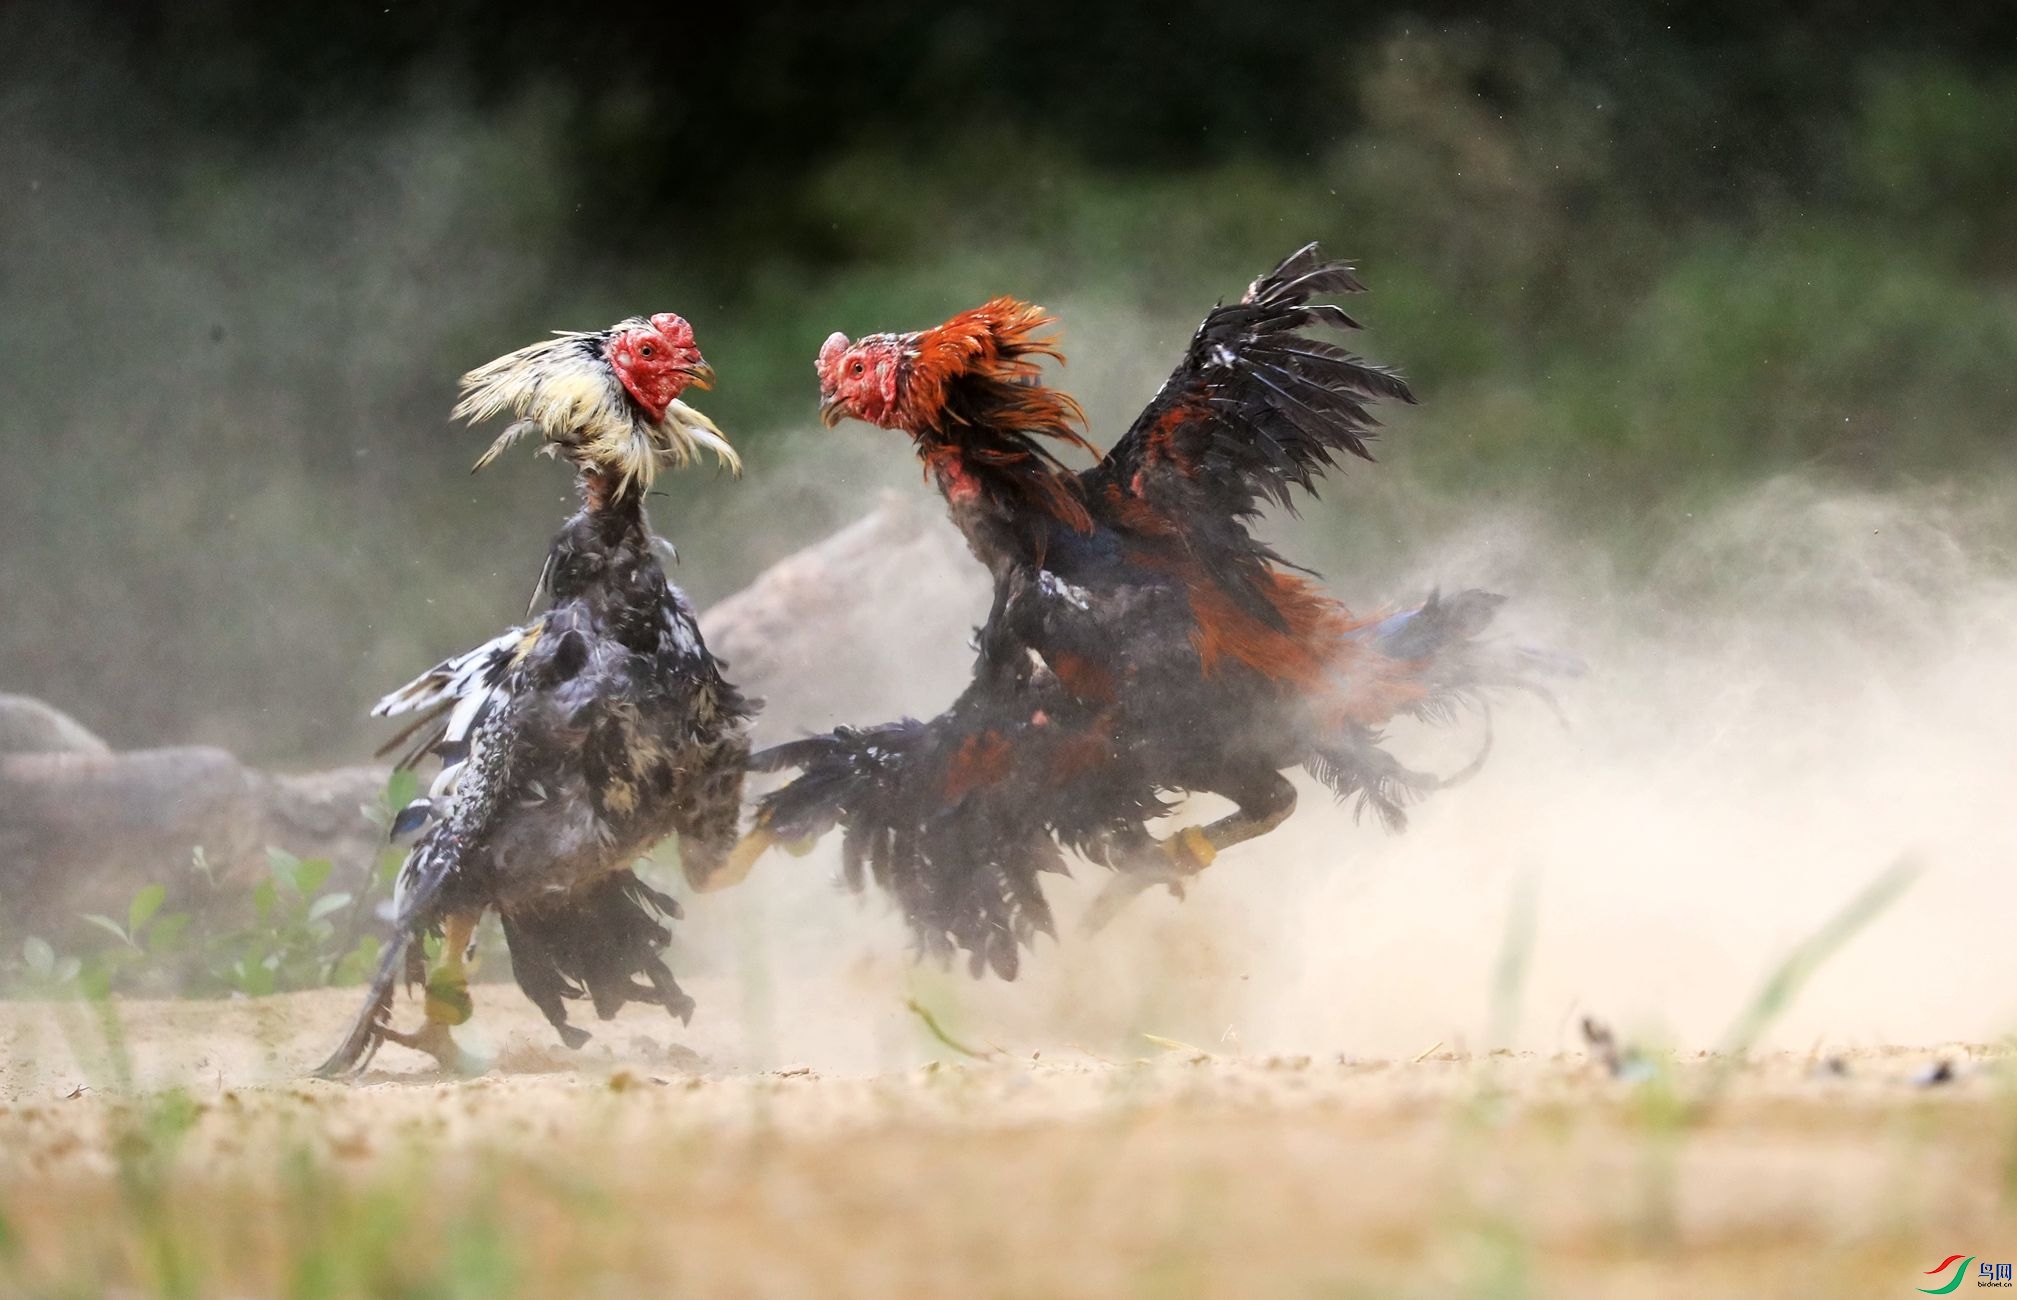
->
[{"left": 1087, "top": 244, "right": 1414, "bottom": 612}]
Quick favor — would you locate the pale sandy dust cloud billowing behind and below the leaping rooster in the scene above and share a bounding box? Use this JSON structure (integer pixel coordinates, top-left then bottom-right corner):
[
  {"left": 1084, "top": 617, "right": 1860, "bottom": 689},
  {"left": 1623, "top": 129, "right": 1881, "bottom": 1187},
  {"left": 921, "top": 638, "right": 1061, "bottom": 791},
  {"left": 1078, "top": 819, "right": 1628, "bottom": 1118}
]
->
[{"left": 680, "top": 471, "right": 2017, "bottom": 1070}]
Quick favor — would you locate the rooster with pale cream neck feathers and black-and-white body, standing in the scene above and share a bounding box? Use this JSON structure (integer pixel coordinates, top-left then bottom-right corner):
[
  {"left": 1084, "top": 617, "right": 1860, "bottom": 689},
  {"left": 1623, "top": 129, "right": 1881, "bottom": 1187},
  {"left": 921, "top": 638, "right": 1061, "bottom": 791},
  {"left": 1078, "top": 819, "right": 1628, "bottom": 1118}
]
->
[{"left": 317, "top": 312, "right": 752, "bottom": 1076}]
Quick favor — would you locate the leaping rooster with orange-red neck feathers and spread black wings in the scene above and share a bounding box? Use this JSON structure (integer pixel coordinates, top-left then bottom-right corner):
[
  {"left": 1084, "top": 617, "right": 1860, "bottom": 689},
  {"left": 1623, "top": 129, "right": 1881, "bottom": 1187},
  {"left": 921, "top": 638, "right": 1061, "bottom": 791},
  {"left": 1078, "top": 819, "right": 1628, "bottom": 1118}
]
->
[{"left": 714, "top": 246, "right": 1557, "bottom": 978}]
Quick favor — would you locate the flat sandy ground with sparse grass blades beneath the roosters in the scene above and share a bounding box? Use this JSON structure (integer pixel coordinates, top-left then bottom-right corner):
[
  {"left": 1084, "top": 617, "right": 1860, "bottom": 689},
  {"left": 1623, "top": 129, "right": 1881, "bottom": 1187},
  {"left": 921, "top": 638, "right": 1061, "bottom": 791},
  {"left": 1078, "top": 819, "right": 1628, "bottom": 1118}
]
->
[{"left": 0, "top": 988, "right": 2017, "bottom": 1298}]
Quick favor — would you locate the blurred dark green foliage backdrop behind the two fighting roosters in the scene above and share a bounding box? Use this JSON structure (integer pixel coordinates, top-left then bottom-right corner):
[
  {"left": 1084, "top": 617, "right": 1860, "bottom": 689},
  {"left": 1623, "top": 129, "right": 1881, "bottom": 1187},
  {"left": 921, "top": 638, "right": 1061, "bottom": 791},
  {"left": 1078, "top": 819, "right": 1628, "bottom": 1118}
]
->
[{"left": 0, "top": 10, "right": 2017, "bottom": 762}]
